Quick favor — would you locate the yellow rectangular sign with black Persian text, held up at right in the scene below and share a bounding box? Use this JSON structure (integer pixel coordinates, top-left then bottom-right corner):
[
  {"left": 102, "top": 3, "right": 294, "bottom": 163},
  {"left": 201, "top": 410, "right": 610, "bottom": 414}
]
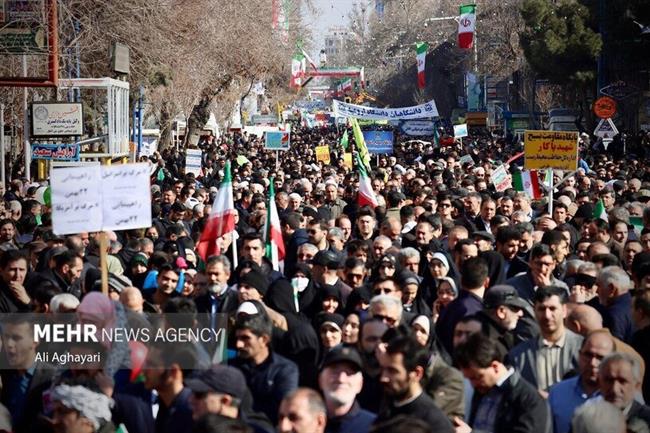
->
[{"left": 524, "top": 131, "right": 578, "bottom": 171}]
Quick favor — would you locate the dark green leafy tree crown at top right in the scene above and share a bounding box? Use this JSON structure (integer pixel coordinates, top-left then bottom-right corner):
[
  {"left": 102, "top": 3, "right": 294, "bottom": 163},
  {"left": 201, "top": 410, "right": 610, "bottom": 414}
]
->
[{"left": 519, "top": 0, "right": 602, "bottom": 84}]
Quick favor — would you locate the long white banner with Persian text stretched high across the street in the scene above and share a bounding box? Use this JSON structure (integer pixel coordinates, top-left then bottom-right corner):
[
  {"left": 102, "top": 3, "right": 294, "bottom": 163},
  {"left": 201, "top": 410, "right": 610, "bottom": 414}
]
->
[{"left": 332, "top": 99, "right": 438, "bottom": 120}]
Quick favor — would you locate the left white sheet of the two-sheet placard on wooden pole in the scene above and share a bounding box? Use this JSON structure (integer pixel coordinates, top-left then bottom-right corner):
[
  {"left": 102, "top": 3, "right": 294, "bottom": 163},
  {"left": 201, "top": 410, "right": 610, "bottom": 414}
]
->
[{"left": 50, "top": 165, "right": 102, "bottom": 235}]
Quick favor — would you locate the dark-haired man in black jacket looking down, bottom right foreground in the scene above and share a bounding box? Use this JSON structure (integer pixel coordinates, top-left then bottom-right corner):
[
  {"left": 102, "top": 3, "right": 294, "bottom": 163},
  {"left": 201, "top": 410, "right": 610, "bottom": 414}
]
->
[{"left": 454, "top": 333, "right": 552, "bottom": 433}]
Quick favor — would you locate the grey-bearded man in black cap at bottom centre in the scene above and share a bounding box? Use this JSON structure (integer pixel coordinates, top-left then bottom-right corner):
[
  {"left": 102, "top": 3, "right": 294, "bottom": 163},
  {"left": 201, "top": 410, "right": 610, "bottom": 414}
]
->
[{"left": 318, "top": 347, "right": 376, "bottom": 433}]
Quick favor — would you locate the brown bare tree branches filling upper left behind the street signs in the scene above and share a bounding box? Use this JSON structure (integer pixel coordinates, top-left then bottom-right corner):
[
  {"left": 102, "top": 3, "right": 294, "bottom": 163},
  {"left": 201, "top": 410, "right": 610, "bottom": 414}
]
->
[{"left": 0, "top": 0, "right": 310, "bottom": 152}]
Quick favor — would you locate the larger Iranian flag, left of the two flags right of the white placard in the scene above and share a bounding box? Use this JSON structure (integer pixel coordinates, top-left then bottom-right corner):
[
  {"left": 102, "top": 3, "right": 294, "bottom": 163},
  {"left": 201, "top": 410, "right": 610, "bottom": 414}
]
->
[{"left": 196, "top": 161, "right": 236, "bottom": 261}]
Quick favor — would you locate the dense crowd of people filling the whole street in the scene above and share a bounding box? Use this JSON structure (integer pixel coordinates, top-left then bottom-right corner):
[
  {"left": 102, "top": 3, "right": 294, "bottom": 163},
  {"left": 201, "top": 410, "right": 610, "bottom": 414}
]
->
[{"left": 0, "top": 120, "right": 650, "bottom": 433}]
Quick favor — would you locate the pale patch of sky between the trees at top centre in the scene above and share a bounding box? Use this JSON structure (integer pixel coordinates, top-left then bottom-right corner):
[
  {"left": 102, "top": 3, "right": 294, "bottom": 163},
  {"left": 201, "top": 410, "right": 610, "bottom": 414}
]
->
[{"left": 303, "top": 0, "right": 354, "bottom": 56}]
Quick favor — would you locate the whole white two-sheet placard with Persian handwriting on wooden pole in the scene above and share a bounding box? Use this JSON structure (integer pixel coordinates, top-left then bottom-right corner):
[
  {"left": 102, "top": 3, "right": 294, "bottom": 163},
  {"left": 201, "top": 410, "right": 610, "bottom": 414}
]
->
[{"left": 50, "top": 163, "right": 151, "bottom": 235}]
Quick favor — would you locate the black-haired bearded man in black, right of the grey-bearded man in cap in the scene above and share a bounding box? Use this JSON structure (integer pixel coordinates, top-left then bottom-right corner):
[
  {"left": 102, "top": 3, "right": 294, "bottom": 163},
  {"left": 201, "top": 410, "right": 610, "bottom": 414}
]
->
[{"left": 376, "top": 335, "right": 454, "bottom": 433}]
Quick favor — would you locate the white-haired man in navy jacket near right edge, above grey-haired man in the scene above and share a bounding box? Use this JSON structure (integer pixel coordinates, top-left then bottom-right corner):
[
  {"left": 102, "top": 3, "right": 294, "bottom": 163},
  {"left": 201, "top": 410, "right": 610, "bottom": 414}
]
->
[{"left": 596, "top": 266, "right": 634, "bottom": 342}]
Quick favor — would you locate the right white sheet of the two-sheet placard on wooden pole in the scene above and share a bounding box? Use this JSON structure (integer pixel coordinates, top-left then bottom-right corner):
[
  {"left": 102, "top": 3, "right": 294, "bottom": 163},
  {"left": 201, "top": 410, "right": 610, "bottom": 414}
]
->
[{"left": 101, "top": 164, "right": 151, "bottom": 230}]
